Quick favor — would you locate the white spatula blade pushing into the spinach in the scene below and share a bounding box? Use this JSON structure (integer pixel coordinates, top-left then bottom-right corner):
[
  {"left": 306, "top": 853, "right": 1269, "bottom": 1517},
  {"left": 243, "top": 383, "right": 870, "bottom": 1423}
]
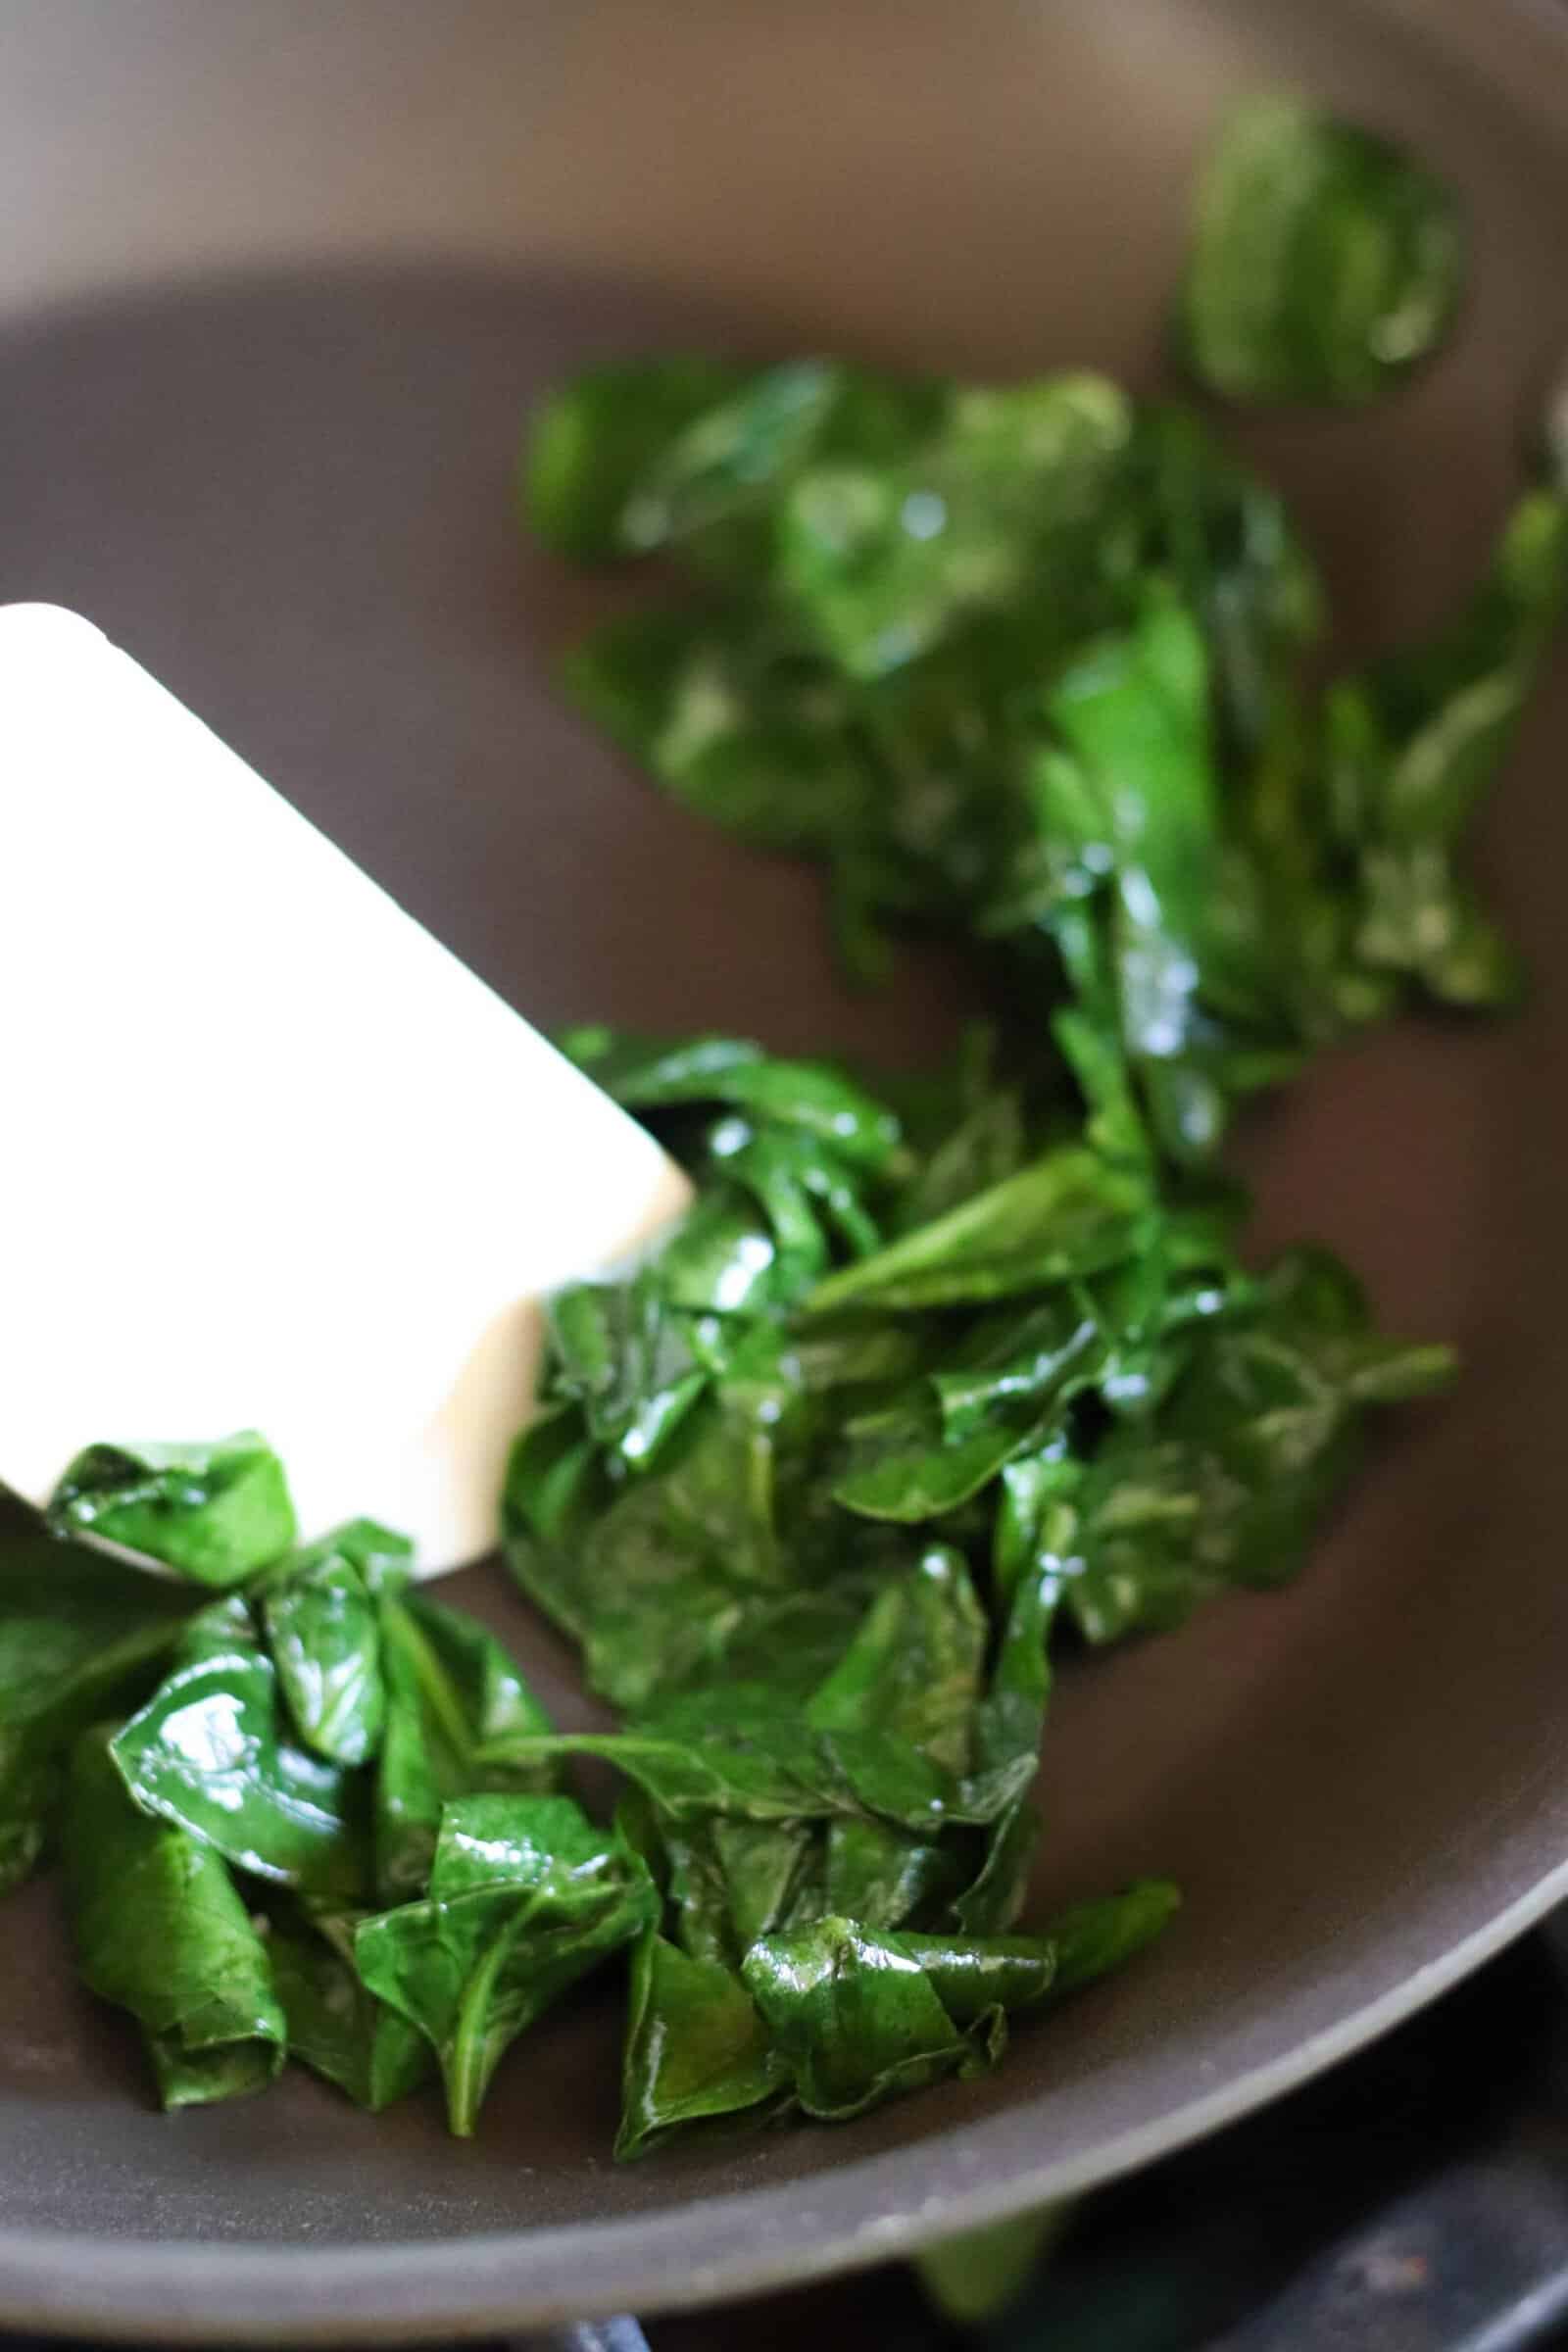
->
[{"left": 0, "top": 605, "right": 686, "bottom": 1574}]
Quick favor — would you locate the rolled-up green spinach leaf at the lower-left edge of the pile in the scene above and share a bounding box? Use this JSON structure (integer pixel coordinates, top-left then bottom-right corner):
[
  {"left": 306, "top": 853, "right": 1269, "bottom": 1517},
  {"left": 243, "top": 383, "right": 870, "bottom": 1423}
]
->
[{"left": 64, "top": 1727, "right": 287, "bottom": 2107}]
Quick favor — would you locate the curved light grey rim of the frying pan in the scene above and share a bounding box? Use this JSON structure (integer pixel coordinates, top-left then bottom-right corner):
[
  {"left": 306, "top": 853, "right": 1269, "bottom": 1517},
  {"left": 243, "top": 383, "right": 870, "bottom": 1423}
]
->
[{"left": 0, "top": 0, "right": 1568, "bottom": 2345}]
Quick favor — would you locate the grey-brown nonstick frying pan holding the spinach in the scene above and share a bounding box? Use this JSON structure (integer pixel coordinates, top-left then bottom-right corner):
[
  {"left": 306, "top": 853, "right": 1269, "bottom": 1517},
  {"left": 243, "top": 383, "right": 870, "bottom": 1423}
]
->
[{"left": 0, "top": 0, "right": 1568, "bottom": 2342}]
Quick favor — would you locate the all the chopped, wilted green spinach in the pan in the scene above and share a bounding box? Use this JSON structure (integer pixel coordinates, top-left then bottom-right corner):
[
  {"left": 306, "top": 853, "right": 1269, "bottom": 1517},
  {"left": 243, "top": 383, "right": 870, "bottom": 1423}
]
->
[{"left": 0, "top": 99, "right": 1542, "bottom": 2157}]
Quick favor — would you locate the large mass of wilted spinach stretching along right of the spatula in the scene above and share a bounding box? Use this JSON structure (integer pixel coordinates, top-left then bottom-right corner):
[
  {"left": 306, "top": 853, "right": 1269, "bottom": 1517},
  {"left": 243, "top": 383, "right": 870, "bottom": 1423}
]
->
[{"left": 482, "top": 99, "right": 1523, "bottom": 2154}]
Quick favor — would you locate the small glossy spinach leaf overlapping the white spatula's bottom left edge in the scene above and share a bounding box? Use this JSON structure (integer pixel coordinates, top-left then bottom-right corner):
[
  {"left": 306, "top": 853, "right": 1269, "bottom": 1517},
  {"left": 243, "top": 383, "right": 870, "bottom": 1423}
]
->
[{"left": 49, "top": 1430, "right": 294, "bottom": 1586}]
